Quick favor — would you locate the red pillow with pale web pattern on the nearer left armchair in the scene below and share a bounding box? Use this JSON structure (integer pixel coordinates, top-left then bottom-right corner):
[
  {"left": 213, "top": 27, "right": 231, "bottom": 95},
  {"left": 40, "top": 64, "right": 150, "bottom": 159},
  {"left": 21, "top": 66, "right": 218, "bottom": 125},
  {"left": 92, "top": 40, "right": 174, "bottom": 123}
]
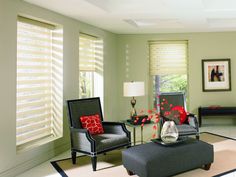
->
[{"left": 80, "top": 114, "right": 104, "bottom": 135}]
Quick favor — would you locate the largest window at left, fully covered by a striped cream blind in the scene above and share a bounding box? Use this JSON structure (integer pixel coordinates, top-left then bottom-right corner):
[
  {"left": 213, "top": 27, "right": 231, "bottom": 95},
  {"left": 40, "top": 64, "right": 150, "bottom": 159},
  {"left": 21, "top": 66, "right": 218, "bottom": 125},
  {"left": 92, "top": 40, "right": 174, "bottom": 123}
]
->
[{"left": 16, "top": 16, "right": 63, "bottom": 150}]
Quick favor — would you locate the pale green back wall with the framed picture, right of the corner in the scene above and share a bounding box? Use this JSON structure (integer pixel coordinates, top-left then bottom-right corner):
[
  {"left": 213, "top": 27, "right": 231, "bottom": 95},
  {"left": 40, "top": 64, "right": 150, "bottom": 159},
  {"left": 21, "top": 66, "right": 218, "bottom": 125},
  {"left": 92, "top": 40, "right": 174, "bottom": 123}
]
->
[{"left": 118, "top": 32, "right": 236, "bottom": 118}]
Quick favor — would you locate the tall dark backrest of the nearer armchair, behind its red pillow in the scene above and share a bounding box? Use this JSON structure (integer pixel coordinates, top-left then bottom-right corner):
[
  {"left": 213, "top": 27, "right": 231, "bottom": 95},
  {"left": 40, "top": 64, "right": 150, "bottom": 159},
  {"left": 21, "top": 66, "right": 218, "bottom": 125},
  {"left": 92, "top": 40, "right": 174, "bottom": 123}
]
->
[{"left": 67, "top": 97, "right": 103, "bottom": 128}]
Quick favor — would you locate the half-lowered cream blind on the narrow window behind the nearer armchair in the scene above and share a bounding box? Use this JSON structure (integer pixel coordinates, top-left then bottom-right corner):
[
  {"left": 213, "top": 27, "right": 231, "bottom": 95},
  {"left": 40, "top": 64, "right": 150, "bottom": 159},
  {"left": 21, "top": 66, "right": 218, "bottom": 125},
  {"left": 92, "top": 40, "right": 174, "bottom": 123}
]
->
[{"left": 79, "top": 33, "right": 103, "bottom": 73}]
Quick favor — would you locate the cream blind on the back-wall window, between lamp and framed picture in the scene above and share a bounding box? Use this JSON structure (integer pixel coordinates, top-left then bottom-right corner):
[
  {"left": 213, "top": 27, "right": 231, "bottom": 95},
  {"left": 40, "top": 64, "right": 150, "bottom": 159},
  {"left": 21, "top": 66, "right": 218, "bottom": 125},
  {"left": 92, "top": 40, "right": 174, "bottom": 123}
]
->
[{"left": 149, "top": 41, "right": 188, "bottom": 75}]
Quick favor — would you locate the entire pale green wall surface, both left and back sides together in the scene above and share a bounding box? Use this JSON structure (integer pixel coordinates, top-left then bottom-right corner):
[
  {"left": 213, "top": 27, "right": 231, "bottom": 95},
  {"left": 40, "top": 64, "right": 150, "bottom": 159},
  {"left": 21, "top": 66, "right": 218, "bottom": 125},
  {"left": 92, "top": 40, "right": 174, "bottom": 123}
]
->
[{"left": 0, "top": 0, "right": 236, "bottom": 177}]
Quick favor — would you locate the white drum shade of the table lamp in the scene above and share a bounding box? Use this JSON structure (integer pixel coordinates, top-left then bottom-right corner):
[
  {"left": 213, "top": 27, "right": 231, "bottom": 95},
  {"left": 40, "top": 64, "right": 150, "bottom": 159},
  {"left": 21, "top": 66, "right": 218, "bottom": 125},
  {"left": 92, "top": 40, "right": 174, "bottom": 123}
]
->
[{"left": 123, "top": 82, "right": 145, "bottom": 97}]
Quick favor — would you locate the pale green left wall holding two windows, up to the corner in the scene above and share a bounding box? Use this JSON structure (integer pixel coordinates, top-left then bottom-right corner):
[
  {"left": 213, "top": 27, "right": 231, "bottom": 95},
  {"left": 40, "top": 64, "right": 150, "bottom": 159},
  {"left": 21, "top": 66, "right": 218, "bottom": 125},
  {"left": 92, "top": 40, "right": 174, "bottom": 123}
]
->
[{"left": 0, "top": 0, "right": 118, "bottom": 177}]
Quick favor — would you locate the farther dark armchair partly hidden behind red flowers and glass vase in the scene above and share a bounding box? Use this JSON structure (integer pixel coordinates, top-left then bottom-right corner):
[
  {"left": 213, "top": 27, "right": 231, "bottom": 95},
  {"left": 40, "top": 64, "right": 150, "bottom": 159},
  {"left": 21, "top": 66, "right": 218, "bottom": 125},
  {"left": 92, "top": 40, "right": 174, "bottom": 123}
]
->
[{"left": 159, "top": 92, "right": 199, "bottom": 139}]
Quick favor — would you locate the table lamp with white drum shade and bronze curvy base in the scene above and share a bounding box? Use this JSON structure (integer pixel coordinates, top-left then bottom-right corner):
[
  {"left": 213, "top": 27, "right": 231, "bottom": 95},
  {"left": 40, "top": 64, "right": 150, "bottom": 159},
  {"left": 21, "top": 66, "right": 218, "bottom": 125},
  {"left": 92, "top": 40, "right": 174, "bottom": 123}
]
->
[{"left": 123, "top": 81, "right": 145, "bottom": 118}]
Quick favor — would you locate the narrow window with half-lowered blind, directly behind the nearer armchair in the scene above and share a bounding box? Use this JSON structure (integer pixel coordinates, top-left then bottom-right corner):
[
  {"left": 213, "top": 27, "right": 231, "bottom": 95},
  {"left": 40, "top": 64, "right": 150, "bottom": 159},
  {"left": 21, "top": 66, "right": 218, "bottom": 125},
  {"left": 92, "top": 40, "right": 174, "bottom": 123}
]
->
[{"left": 79, "top": 33, "right": 103, "bottom": 102}]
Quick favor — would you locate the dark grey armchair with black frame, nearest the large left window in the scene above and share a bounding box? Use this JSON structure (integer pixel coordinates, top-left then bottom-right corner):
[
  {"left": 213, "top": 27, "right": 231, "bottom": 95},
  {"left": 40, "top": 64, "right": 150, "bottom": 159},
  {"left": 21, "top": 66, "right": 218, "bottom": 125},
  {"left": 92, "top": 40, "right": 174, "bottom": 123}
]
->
[{"left": 67, "top": 98, "right": 131, "bottom": 171}]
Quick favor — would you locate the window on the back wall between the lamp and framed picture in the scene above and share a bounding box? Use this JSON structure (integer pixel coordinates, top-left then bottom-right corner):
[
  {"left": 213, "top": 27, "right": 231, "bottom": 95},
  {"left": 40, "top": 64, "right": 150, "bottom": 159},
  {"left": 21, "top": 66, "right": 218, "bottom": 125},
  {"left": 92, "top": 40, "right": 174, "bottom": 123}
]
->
[{"left": 149, "top": 41, "right": 187, "bottom": 105}]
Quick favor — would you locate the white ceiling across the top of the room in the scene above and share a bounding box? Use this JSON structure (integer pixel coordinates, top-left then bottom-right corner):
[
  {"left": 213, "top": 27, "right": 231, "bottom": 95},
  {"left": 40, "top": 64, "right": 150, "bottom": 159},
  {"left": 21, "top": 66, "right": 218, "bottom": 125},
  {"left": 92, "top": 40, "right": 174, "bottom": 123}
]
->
[{"left": 24, "top": 0, "right": 236, "bottom": 34}]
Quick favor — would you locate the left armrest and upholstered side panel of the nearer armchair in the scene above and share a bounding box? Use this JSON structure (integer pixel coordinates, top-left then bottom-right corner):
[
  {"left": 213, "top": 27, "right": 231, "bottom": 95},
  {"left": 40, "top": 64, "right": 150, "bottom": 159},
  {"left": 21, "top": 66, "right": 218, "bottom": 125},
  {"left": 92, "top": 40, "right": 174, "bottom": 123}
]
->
[{"left": 70, "top": 127, "right": 95, "bottom": 152}]
